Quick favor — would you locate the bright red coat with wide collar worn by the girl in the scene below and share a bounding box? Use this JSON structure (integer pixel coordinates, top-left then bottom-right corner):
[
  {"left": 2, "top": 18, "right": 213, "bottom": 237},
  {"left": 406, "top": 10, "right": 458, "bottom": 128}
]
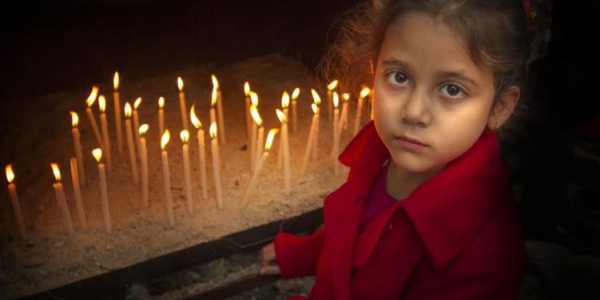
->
[{"left": 275, "top": 122, "right": 527, "bottom": 300}]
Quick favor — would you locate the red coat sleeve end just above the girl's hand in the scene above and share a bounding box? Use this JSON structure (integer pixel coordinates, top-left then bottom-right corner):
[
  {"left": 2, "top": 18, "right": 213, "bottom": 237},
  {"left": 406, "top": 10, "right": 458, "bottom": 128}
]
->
[{"left": 275, "top": 226, "right": 325, "bottom": 278}]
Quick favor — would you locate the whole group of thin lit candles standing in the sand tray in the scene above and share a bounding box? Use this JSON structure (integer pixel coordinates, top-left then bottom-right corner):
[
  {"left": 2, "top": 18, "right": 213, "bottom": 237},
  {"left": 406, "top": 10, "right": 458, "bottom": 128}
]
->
[{"left": 6, "top": 72, "right": 370, "bottom": 239}]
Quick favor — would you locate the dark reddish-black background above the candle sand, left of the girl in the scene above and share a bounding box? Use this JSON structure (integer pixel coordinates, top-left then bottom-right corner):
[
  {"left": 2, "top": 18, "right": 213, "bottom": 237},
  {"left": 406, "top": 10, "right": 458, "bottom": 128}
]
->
[{"left": 0, "top": 0, "right": 356, "bottom": 101}]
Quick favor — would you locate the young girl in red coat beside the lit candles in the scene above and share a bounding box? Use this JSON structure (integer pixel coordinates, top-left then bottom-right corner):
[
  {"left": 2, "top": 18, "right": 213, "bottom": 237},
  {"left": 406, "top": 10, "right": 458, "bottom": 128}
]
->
[{"left": 261, "top": 0, "right": 528, "bottom": 300}]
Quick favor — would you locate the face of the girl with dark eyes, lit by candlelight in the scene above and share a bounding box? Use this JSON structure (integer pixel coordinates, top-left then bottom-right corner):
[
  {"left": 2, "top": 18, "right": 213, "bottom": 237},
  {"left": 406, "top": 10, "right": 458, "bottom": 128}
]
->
[{"left": 372, "top": 13, "right": 496, "bottom": 174}]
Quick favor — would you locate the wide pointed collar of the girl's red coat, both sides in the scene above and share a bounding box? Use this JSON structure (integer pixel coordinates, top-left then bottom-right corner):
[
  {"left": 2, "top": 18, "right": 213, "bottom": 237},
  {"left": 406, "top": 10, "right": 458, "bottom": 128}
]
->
[{"left": 340, "top": 121, "right": 512, "bottom": 267}]
